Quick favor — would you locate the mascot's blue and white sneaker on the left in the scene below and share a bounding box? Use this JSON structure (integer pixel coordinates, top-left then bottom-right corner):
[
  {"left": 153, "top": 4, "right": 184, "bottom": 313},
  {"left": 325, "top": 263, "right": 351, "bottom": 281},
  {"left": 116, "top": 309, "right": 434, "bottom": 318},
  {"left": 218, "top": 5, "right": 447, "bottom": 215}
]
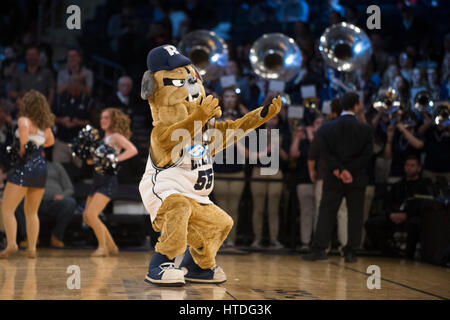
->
[{"left": 145, "top": 251, "right": 186, "bottom": 286}]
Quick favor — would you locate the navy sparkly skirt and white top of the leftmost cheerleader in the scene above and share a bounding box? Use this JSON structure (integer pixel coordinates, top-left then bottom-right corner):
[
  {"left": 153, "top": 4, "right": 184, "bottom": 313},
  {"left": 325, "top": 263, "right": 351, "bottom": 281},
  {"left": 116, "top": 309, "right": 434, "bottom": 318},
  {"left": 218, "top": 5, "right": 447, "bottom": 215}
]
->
[{"left": 7, "top": 129, "right": 47, "bottom": 188}]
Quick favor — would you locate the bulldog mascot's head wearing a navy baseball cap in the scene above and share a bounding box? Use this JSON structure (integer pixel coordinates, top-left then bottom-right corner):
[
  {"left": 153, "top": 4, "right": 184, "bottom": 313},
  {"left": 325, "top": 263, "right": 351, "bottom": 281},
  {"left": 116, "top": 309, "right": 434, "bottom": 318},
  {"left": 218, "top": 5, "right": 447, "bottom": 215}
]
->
[{"left": 141, "top": 45, "right": 205, "bottom": 127}]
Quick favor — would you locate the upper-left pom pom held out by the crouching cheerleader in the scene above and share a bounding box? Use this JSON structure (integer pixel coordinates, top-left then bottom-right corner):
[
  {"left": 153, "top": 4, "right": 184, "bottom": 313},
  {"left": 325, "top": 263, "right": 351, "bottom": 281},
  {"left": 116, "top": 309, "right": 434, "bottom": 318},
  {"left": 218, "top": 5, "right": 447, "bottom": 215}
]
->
[{"left": 70, "top": 125, "right": 101, "bottom": 160}]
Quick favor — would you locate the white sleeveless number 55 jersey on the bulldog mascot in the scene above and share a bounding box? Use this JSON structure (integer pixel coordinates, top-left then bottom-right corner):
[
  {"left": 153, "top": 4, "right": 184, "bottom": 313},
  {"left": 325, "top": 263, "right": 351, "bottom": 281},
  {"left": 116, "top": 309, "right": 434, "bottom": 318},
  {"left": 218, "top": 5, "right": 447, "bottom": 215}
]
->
[{"left": 139, "top": 144, "right": 214, "bottom": 222}]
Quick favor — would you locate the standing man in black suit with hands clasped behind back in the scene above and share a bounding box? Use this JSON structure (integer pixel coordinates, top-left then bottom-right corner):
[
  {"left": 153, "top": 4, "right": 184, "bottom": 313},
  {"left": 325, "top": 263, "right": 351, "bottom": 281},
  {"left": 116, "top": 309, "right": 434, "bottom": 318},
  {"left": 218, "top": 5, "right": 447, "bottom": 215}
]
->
[{"left": 303, "top": 92, "right": 373, "bottom": 262}]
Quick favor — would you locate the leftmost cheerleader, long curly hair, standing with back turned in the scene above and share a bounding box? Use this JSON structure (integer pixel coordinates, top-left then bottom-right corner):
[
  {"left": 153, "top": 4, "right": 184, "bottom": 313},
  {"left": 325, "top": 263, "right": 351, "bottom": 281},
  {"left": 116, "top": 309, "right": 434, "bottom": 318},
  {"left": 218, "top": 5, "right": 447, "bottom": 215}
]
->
[{"left": 0, "top": 90, "right": 55, "bottom": 258}]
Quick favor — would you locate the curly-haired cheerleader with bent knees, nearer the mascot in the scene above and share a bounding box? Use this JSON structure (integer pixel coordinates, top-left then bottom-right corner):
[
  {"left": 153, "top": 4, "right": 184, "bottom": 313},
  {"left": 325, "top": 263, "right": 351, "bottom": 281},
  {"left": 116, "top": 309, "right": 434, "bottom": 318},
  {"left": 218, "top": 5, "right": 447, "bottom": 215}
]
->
[{"left": 83, "top": 108, "right": 138, "bottom": 257}]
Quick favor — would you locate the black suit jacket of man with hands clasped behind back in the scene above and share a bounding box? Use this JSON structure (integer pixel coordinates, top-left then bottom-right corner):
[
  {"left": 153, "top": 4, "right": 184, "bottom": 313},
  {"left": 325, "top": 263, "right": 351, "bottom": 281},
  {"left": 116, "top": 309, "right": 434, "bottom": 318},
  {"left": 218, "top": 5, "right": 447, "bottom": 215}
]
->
[{"left": 319, "top": 115, "right": 374, "bottom": 184}]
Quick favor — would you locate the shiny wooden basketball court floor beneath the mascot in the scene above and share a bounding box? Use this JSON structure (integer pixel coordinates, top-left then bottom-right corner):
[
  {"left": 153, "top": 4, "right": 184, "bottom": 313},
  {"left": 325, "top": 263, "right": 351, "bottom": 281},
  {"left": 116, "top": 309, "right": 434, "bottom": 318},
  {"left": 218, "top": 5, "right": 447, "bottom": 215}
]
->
[{"left": 0, "top": 249, "right": 450, "bottom": 300}]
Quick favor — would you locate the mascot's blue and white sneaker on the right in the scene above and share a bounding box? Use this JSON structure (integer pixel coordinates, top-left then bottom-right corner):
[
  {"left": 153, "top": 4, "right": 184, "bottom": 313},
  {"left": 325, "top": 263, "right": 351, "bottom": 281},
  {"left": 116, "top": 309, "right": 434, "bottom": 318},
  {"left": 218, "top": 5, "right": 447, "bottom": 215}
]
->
[{"left": 180, "top": 248, "right": 227, "bottom": 283}]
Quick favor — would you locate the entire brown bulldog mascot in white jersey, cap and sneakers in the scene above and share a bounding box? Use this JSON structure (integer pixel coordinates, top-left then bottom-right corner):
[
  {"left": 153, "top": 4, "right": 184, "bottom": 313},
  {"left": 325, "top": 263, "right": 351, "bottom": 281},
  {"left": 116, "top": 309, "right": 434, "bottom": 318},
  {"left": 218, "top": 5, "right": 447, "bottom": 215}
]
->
[{"left": 139, "top": 45, "right": 281, "bottom": 286}]
